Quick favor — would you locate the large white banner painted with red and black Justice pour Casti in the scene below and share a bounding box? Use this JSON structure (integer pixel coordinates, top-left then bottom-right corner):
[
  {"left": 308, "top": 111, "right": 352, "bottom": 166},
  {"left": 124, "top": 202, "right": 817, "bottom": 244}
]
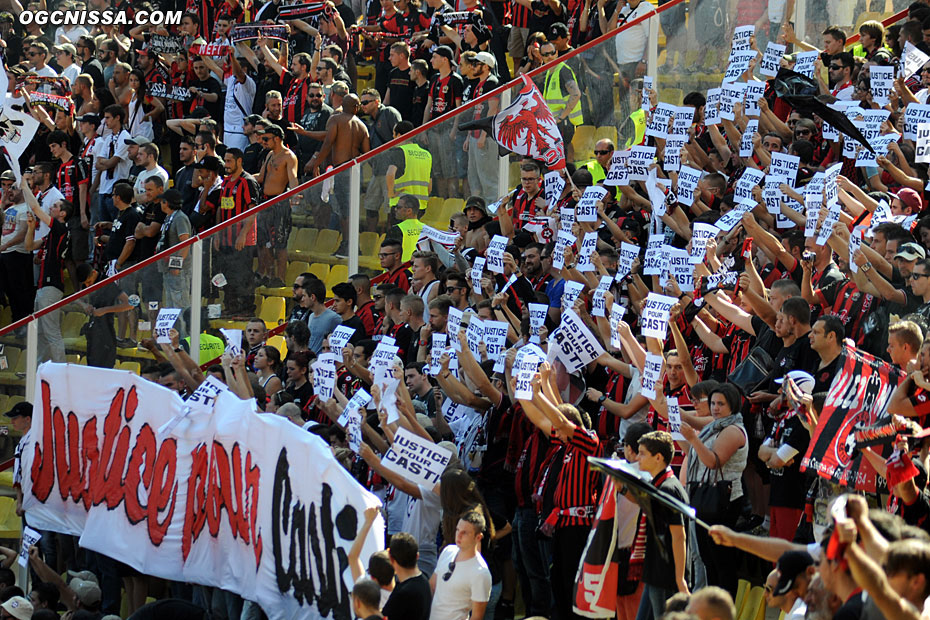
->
[{"left": 22, "top": 363, "right": 383, "bottom": 620}]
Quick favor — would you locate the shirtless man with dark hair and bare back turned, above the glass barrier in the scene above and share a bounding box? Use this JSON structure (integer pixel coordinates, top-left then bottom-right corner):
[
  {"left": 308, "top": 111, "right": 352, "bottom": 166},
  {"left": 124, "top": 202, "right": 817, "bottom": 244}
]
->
[{"left": 307, "top": 94, "right": 371, "bottom": 255}]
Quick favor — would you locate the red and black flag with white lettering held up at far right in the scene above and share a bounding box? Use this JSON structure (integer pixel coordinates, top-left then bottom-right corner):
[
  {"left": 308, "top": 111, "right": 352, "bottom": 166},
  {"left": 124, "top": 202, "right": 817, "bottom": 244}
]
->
[{"left": 801, "top": 347, "right": 902, "bottom": 493}]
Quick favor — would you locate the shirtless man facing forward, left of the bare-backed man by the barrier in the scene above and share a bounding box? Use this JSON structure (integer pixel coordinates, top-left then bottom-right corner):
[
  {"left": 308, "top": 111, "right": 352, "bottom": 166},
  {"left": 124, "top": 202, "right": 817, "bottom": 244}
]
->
[{"left": 256, "top": 125, "right": 300, "bottom": 287}]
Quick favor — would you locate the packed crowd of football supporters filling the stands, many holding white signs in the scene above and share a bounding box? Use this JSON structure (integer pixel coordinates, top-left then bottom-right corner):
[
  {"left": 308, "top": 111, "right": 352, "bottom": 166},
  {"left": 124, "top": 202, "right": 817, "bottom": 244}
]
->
[{"left": 7, "top": 0, "right": 930, "bottom": 620}]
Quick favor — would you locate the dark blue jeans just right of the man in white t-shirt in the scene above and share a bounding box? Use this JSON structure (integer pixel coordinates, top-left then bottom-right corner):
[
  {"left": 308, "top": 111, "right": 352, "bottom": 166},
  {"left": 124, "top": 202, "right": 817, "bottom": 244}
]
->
[{"left": 513, "top": 508, "right": 552, "bottom": 618}]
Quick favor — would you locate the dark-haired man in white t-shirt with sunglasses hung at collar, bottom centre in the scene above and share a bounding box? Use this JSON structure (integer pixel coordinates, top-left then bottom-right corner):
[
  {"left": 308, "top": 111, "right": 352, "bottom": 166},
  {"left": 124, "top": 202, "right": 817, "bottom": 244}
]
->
[{"left": 430, "top": 511, "right": 491, "bottom": 620}]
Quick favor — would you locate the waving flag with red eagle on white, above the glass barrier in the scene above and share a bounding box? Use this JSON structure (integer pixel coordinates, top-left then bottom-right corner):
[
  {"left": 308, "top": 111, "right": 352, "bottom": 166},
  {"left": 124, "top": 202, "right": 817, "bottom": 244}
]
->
[{"left": 459, "top": 75, "right": 565, "bottom": 170}]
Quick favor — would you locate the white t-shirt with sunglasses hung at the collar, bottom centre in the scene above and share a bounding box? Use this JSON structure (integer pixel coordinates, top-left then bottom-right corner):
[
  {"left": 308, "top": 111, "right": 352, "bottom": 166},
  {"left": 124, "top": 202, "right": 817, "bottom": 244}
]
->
[{"left": 429, "top": 545, "right": 491, "bottom": 620}]
